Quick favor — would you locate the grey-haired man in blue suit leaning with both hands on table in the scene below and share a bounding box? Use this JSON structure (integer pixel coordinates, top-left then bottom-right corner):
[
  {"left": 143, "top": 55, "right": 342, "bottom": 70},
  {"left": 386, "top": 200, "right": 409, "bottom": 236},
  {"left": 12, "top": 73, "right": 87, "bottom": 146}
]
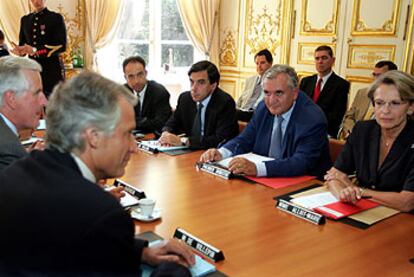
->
[{"left": 200, "top": 65, "right": 331, "bottom": 178}]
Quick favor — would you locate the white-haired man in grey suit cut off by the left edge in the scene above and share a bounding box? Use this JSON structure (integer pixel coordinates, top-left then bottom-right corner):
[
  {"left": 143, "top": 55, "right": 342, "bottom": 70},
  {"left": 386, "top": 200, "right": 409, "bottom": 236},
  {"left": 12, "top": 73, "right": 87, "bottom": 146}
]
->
[{"left": 0, "top": 56, "right": 47, "bottom": 171}]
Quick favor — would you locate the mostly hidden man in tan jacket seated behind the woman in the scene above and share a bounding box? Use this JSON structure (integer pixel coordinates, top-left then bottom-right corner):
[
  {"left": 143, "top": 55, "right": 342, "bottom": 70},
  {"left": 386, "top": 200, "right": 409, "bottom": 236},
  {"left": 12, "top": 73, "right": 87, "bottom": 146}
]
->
[{"left": 338, "top": 61, "right": 398, "bottom": 140}]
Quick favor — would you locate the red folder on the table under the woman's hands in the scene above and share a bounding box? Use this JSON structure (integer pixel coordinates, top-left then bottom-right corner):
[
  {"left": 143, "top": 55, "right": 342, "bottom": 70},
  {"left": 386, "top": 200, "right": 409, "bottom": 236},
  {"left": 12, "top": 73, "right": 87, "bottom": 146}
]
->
[{"left": 314, "top": 199, "right": 379, "bottom": 219}]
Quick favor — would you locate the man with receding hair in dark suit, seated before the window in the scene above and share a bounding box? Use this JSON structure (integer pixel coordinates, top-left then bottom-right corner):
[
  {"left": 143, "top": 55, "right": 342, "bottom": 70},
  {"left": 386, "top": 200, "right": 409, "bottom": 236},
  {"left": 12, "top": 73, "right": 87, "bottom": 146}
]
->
[{"left": 122, "top": 56, "right": 171, "bottom": 135}]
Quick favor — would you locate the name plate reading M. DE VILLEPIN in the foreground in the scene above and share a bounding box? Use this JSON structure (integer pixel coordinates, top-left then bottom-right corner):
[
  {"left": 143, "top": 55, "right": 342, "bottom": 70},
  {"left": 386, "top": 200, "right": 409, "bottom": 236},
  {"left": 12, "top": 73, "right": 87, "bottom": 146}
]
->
[{"left": 174, "top": 228, "right": 224, "bottom": 262}]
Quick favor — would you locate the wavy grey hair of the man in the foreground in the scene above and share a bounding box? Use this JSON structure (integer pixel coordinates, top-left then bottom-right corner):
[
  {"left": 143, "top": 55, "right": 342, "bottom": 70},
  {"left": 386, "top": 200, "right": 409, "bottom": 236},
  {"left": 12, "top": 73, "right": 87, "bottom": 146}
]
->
[{"left": 46, "top": 72, "right": 137, "bottom": 152}]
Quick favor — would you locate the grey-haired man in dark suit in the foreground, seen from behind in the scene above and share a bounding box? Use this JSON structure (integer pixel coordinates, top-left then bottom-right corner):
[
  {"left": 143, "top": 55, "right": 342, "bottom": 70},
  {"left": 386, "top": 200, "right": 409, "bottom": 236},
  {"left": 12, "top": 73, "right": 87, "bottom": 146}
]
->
[{"left": 0, "top": 72, "right": 194, "bottom": 276}]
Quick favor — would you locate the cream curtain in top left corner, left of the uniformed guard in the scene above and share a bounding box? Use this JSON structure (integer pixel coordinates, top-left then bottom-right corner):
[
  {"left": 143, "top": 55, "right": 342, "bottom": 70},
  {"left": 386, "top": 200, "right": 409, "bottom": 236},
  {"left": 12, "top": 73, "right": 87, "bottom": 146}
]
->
[{"left": 0, "top": 0, "right": 30, "bottom": 46}]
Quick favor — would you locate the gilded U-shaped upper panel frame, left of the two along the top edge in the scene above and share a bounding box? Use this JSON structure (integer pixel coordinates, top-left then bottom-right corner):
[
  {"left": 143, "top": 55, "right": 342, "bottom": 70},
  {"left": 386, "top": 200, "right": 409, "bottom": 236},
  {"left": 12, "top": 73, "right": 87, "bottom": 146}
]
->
[{"left": 300, "top": 0, "right": 339, "bottom": 36}]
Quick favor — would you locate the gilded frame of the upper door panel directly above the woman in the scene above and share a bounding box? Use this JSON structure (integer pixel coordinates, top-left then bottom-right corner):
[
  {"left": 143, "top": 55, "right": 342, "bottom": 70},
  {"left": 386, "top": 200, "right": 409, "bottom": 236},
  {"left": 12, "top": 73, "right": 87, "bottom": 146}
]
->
[{"left": 351, "top": 0, "right": 400, "bottom": 36}]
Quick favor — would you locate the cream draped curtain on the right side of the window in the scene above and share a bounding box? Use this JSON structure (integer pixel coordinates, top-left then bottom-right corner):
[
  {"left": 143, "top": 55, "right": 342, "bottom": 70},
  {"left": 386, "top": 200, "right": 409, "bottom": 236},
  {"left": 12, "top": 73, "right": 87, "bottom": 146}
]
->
[{"left": 177, "top": 0, "right": 220, "bottom": 66}]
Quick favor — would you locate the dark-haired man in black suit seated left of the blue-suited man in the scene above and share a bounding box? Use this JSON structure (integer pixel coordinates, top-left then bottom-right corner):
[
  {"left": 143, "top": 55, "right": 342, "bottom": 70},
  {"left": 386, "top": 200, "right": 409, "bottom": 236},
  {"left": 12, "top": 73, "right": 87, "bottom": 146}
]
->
[{"left": 160, "top": 61, "right": 238, "bottom": 149}]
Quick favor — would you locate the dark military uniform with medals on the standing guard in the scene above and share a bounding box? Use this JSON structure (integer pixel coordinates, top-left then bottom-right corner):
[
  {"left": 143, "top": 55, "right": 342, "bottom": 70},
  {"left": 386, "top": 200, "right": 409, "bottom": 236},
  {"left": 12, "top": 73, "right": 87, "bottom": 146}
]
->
[{"left": 19, "top": 8, "right": 66, "bottom": 96}]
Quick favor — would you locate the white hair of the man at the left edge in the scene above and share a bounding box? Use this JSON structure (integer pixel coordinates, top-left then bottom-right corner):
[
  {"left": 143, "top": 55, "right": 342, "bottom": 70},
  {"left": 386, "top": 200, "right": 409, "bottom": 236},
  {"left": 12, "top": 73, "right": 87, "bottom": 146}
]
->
[{"left": 0, "top": 56, "right": 42, "bottom": 107}]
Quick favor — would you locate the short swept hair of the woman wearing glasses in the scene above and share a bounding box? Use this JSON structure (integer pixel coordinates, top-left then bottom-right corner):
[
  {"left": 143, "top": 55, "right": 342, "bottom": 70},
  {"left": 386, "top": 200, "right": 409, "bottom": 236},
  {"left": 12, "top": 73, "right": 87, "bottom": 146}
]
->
[{"left": 368, "top": 70, "right": 414, "bottom": 103}]
